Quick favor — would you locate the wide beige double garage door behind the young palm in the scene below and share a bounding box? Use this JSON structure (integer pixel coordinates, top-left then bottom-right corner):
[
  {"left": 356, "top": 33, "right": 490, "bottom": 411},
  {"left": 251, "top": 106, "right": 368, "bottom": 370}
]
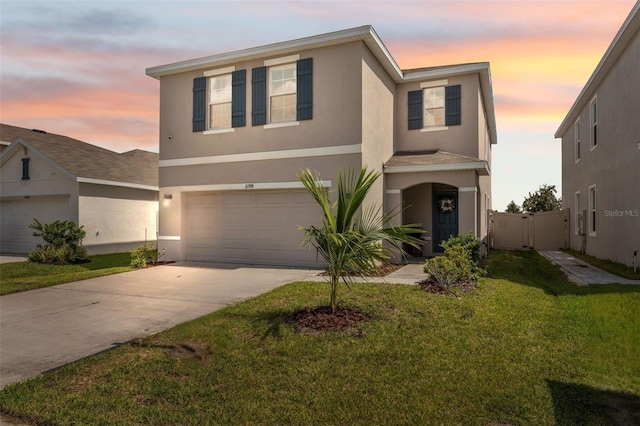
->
[{"left": 187, "top": 190, "right": 321, "bottom": 266}]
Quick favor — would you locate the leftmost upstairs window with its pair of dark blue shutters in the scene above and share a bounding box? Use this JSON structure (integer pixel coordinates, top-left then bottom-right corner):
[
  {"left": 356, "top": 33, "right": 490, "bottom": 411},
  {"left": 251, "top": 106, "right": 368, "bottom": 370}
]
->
[{"left": 193, "top": 67, "right": 247, "bottom": 133}]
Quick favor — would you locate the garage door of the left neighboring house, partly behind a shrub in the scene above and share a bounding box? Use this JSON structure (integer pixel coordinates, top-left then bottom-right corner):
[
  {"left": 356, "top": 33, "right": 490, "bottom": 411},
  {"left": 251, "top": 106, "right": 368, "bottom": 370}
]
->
[{"left": 0, "top": 198, "right": 70, "bottom": 254}]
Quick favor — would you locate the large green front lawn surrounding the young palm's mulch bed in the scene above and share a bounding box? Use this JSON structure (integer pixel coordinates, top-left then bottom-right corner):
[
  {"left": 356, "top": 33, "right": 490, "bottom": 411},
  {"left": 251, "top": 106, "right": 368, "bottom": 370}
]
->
[{"left": 0, "top": 251, "right": 640, "bottom": 425}]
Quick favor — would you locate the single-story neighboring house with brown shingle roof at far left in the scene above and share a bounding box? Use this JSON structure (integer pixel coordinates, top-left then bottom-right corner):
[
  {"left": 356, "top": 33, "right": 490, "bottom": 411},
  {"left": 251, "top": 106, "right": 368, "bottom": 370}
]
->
[{"left": 0, "top": 124, "right": 158, "bottom": 254}]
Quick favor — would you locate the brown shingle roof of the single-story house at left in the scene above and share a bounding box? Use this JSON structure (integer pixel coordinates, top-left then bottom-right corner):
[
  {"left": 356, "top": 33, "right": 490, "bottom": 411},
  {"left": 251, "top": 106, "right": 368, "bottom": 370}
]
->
[{"left": 0, "top": 124, "right": 158, "bottom": 187}]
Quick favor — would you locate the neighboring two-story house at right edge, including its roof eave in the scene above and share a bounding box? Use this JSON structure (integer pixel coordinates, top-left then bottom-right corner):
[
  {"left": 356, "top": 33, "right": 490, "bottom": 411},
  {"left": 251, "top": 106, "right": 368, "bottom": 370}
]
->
[{"left": 555, "top": 3, "right": 640, "bottom": 265}]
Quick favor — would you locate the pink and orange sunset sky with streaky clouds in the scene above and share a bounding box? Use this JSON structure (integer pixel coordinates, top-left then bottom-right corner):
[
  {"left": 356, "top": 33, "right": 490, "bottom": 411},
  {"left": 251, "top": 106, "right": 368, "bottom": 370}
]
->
[{"left": 0, "top": 0, "right": 635, "bottom": 210}]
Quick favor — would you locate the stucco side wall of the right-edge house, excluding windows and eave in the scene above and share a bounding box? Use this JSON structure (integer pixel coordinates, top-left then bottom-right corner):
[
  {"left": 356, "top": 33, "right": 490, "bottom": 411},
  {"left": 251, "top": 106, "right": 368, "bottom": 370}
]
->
[{"left": 562, "top": 30, "right": 640, "bottom": 265}]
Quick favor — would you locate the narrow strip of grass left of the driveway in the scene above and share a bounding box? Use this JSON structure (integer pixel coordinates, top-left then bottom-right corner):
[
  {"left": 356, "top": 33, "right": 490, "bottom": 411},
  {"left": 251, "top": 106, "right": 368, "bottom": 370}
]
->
[{"left": 0, "top": 253, "right": 133, "bottom": 295}]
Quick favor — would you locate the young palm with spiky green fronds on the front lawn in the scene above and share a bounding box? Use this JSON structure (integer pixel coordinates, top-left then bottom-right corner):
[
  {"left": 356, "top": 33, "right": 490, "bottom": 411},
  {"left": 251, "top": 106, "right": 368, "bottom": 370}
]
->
[{"left": 298, "top": 168, "right": 424, "bottom": 313}]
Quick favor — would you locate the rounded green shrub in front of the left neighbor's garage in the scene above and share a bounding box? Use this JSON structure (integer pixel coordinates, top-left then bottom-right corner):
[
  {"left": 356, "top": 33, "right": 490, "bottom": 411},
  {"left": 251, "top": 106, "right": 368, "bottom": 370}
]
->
[{"left": 27, "top": 218, "right": 89, "bottom": 265}]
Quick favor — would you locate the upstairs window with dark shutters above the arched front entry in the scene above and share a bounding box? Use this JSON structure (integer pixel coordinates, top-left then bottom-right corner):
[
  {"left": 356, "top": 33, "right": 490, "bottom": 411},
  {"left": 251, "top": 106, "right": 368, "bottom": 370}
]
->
[{"left": 408, "top": 80, "right": 462, "bottom": 131}]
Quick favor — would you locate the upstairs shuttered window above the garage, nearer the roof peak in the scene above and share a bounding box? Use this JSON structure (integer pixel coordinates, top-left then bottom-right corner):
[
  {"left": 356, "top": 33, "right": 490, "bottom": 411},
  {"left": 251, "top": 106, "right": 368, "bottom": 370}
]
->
[{"left": 251, "top": 55, "right": 313, "bottom": 127}]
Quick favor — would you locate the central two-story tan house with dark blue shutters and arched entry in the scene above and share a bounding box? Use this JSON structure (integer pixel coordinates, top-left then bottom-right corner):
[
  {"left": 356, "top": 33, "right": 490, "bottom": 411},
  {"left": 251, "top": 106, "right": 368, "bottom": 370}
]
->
[{"left": 147, "top": 26, "right": 496, "bottom": 266}]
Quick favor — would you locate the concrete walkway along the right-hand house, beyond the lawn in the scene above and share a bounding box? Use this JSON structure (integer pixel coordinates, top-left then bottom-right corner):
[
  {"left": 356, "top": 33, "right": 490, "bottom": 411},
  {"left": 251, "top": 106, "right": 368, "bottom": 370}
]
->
[{"left": 539, "top": 250, "right": 640, "bottom": 285}]
